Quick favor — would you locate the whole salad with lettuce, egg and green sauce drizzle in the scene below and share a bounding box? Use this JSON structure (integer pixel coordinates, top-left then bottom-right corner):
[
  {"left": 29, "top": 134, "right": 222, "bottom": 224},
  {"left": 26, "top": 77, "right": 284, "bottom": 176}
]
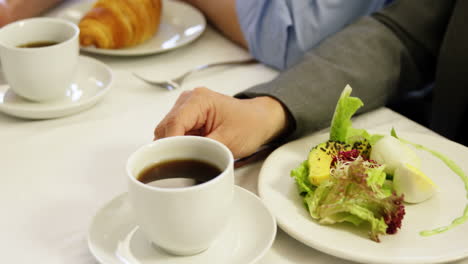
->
[{"left": 291, "top": 85, "right": 468, "bottom": 242}]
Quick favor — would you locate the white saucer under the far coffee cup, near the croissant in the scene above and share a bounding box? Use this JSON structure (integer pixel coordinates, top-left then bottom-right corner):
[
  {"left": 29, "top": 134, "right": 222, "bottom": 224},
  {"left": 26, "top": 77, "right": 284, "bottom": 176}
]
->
[{"left": 0, "top": 56, "right": 112, "bottom": 119}]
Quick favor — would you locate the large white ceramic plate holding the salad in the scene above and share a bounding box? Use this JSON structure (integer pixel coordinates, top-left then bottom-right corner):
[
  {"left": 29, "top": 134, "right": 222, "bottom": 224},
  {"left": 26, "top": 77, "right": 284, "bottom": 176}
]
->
[{"left": 258, "top": 133, "right": 468, "bottom": 264}]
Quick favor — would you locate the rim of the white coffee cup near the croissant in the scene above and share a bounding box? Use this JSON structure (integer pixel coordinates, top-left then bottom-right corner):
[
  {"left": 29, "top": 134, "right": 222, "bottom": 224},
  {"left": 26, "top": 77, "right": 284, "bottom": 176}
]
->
[{"left": 0, "top": 17, "right": 80, "bottom": 52}]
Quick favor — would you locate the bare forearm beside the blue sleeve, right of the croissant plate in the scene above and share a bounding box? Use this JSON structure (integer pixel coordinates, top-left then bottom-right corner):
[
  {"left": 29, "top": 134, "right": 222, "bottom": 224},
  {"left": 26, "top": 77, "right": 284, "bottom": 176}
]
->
[{"left": 183, "top": 0, "right": 247, "bottom": 48}]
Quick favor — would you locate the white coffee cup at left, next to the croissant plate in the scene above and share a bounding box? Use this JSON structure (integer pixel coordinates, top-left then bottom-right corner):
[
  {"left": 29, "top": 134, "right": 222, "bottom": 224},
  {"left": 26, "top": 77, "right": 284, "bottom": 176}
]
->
[{"left": 0, "top": 17, "right": 79, "bottom": 102}]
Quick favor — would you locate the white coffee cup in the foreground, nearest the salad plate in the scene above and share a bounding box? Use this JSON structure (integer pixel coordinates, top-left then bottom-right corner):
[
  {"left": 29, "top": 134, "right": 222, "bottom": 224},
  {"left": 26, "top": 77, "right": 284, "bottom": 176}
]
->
[{"left": 127, "top": 136, "right": 234, "bottom": 255}]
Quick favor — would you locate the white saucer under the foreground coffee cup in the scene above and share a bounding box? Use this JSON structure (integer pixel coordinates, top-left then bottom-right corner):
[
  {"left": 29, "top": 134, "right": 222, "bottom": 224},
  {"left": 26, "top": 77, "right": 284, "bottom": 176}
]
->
[{"left": 88, "top": 186, "right": 276, "bottom": 264}]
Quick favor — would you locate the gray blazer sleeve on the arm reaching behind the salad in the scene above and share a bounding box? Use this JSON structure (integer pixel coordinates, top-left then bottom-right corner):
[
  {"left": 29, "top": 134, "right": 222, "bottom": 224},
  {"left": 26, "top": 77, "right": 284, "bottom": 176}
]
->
[{"left": 236, "top": 0, "right": 453, "bottom": 139}]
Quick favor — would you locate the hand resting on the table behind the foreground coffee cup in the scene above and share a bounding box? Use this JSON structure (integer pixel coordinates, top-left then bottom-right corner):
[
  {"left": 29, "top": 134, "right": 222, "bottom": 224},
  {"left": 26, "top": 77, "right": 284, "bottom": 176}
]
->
[{"left": 154, "top": 88, "right": 287, "bottom": 158}]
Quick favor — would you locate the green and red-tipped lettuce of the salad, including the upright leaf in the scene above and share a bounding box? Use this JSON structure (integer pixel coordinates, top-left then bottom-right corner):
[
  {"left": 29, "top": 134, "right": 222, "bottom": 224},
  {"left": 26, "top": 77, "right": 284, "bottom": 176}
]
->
[{"left": 291, "top": 85, "right": 405, "bottom": 241}]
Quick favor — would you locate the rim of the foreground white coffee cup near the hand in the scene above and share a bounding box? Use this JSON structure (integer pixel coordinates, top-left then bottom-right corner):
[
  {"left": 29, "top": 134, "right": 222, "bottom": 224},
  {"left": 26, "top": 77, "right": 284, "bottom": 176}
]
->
[{"left": 126, "top": 136, "right": 234, "bottom": 193}]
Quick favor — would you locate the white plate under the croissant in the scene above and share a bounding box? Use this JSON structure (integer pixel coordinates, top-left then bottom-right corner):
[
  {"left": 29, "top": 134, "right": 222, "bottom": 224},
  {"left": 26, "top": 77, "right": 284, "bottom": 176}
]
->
[{"left": 55, "top": 0, "right": 206, "bottom": 56}]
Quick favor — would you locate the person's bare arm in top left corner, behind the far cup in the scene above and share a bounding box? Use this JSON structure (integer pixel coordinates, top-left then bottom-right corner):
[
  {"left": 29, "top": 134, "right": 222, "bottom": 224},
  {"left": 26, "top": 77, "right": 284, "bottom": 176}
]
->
[{"left": 0, "top": 0, "right": 61, "bottom": 23}]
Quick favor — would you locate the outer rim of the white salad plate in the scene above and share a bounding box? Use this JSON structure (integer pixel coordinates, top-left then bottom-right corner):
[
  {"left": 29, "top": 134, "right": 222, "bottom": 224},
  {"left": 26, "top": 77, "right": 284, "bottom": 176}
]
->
[{"left": 258, "top": 129, "right": 468, "bottom": 264}]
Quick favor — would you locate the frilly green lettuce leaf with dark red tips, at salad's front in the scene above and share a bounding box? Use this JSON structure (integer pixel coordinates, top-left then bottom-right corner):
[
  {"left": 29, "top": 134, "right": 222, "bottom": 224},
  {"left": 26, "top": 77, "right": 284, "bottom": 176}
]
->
[{"left": 304, "top": 157, "right": 404, "bottom": 241}]
